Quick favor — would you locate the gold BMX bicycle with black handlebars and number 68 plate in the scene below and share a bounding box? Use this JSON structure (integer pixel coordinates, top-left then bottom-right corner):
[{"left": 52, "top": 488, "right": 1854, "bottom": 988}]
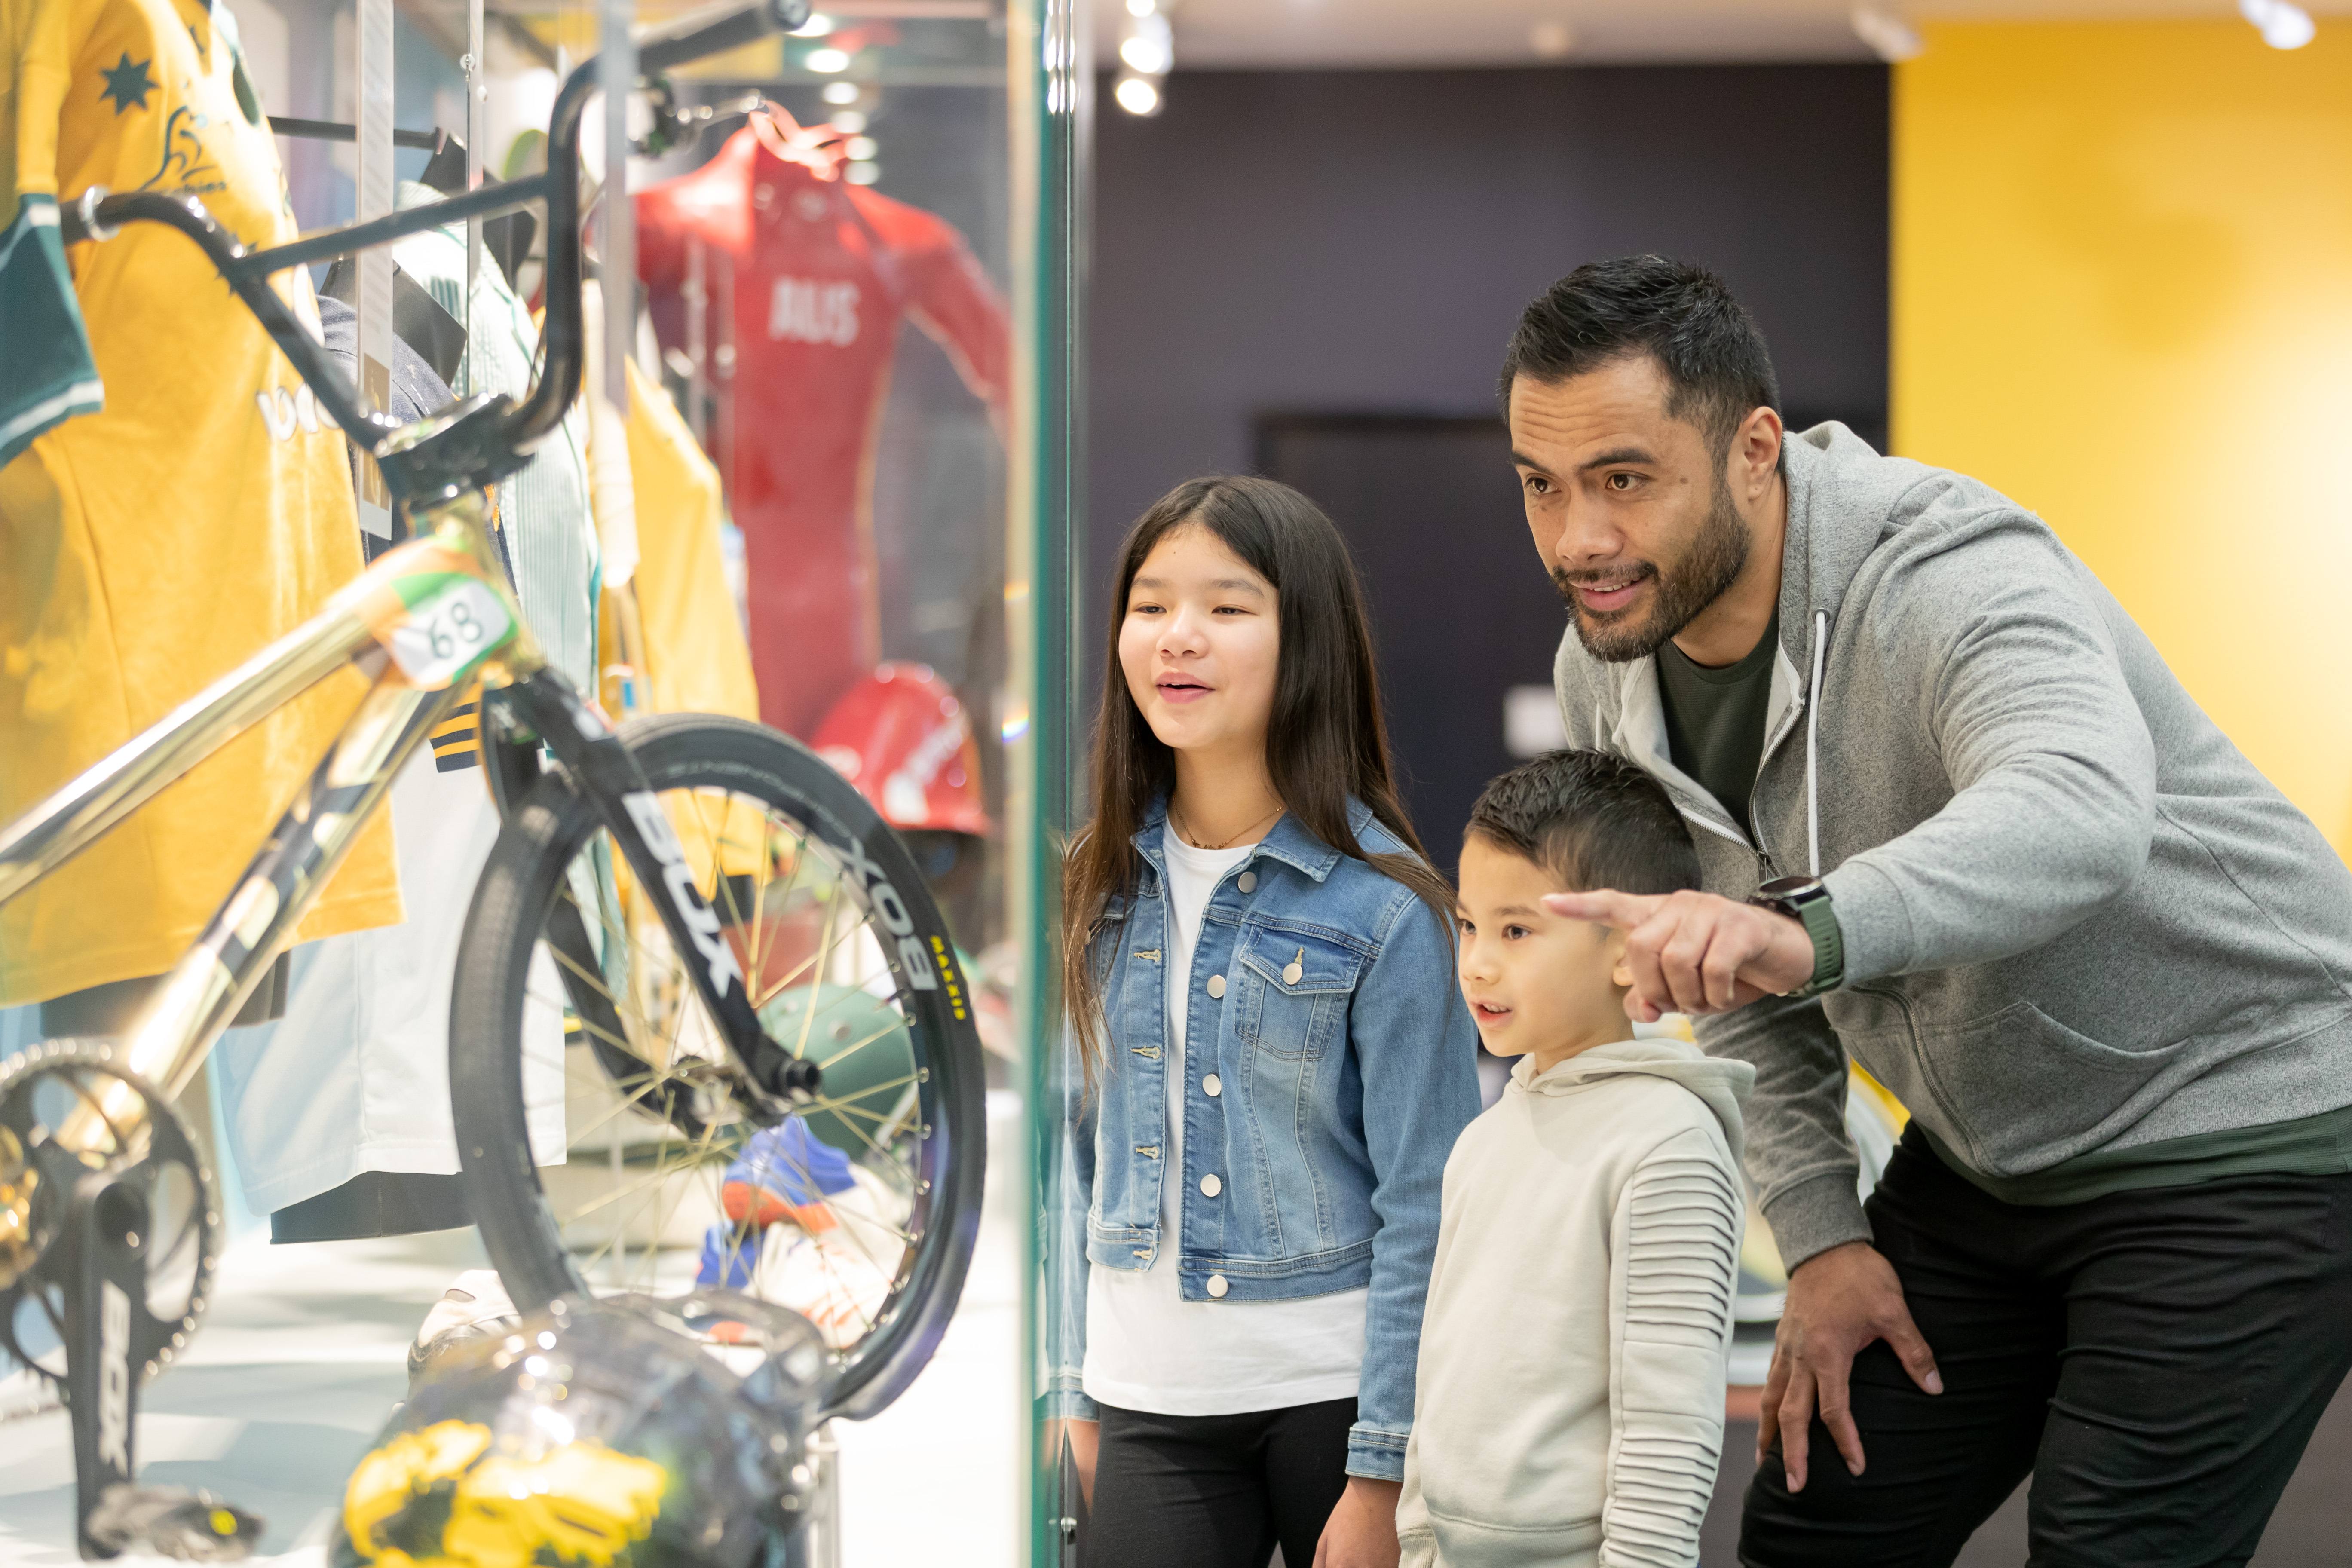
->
[{"left": 0, "top": 0, "right": 986, "bottom": 1556}]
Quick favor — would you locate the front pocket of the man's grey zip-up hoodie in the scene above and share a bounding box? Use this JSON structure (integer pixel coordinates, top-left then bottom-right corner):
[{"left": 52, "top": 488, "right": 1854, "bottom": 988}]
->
[{"left": 1919, "top": 1001, "right": 2194, "bottom": 1176}]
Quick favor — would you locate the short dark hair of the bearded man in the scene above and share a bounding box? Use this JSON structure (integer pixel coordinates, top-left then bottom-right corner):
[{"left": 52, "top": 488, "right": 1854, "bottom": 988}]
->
[{"left": 1501, "top": 256, "right": 1780, "bottom": 456}]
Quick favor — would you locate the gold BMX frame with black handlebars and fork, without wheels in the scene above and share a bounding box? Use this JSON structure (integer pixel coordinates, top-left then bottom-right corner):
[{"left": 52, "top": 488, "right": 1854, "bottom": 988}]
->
[{"left": 0, "top": 0, "right": 818, "bottom": 1147}]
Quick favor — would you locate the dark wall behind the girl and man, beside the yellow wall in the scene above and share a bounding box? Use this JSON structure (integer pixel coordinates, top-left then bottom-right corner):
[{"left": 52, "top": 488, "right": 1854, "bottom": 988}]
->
[{"left": 1084, "top": 66, "right": 1886, "bottom": 861}]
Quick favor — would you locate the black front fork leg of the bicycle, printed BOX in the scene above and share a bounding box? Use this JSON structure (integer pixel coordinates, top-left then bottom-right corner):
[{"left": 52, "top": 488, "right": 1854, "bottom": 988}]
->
[{"left": 499, "top": 670, "right": 821, "bottom": 1105}]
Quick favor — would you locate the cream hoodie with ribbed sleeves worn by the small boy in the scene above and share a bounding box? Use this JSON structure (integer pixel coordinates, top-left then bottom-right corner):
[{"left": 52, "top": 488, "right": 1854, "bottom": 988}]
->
[{"left": 1397, "top": 1039, "right": 1755, "bottom": 1568}]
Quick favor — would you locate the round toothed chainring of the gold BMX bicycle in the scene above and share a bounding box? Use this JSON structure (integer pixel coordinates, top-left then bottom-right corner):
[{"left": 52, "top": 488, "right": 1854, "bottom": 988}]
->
[{"left": 0, "top": 1039, "right": 221, "bottom": 1384}]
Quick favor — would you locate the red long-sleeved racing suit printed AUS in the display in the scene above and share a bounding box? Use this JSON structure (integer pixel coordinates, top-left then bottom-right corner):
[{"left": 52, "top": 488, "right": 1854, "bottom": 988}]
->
[{"left": 635, "top": 127, "right": 1011, "bottom": 736}]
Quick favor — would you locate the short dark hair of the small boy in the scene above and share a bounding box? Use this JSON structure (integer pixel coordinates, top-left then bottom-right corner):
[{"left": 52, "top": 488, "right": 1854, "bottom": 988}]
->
[{"left": 1463, "top": 750, "right": 1698, "bottom": 893}]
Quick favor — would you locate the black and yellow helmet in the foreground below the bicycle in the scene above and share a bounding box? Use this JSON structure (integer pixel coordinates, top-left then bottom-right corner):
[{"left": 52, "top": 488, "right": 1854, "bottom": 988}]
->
[{"left": 332, "top": 1291, "right": 830, "bottom": 1568}]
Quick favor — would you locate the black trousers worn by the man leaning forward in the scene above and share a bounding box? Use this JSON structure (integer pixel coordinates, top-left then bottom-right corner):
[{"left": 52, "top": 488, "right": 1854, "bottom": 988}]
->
[{"left": 1740, "top": 1131, "right": 2352, "bottom": 1568}]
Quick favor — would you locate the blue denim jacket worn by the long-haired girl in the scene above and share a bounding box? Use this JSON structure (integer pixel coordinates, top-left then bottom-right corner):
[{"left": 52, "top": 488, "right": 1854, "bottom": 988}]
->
[{"left": 1047, "top": 802, "right": 1479, "bottom": 1481}]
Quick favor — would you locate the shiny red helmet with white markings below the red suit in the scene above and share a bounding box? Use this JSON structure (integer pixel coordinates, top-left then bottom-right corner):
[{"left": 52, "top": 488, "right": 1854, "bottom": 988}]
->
[{"left": 814, "top": 661, "right": 988, "bottom": 837}]
